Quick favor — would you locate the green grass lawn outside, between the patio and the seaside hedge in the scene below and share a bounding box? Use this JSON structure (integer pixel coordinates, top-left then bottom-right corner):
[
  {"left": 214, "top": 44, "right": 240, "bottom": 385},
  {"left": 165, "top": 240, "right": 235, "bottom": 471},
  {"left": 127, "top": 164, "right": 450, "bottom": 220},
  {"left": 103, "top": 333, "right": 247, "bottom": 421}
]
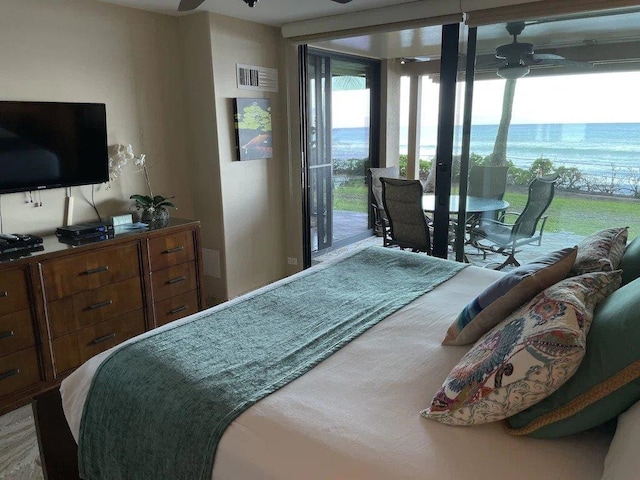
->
[{"left": 333, "top": 182, "right": 640, "bottom": 238}]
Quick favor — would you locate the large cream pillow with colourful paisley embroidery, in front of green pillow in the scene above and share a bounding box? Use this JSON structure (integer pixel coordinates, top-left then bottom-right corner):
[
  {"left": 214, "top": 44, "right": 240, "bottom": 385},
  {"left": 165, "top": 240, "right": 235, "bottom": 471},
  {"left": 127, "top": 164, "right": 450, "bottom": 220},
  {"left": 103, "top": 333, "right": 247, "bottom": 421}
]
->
[{"left": 421, "top": 270, "right": 622, "bottom": 425}]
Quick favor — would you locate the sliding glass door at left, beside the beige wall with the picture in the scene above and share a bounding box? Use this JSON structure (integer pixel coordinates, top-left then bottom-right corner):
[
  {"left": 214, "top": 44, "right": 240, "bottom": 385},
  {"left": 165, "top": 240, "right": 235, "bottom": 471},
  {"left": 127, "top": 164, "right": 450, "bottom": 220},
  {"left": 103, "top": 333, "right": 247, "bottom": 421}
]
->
[{"left": 303, "top": 49, "right": 379, "bottom": 266}]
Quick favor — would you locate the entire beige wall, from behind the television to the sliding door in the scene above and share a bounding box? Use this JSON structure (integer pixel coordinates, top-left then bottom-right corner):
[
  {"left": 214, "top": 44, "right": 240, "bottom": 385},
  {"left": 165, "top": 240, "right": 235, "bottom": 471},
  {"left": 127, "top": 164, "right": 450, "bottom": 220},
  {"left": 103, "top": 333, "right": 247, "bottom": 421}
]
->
[{"left": 0, "top": 0, "right": 299, "bottom": 302}]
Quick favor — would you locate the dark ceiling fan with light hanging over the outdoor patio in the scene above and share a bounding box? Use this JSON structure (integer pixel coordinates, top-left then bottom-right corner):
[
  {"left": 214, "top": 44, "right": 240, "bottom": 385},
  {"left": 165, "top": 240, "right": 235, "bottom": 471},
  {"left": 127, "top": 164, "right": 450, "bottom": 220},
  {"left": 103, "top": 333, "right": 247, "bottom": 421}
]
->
[{"left": 485, "top": 22, "right": 590, "bottom": 80}]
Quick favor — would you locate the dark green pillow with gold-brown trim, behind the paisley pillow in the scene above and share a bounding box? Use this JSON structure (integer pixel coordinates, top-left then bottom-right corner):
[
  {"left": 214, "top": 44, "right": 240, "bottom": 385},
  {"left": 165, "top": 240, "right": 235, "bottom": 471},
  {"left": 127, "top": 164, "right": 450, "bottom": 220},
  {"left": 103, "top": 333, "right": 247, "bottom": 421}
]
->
[{"left": 508, "top": 279, "right": 640, "bottom": 438}]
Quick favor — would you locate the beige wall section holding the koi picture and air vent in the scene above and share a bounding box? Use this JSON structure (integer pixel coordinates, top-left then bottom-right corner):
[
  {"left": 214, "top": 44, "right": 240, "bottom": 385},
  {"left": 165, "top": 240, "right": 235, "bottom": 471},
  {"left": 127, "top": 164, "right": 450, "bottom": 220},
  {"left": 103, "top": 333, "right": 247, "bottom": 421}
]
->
[{"left": 208, "top": 15, "right": 288, "bottom": 298}]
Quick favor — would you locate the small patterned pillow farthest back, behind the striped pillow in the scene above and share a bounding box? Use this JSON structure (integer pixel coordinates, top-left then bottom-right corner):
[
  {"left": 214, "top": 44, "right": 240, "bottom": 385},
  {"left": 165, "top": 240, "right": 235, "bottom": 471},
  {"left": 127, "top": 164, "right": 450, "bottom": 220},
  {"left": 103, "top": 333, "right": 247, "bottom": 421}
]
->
[{"left": 571, "top": 227, "right": 629, "bottom": 275}]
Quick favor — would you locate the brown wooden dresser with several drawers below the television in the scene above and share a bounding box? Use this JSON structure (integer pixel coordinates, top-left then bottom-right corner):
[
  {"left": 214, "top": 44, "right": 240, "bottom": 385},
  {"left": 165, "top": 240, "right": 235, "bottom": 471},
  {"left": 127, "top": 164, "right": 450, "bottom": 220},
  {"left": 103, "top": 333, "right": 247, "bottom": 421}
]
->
[{"left": 0, "top": 219, "right": 205, "bottom": 414}]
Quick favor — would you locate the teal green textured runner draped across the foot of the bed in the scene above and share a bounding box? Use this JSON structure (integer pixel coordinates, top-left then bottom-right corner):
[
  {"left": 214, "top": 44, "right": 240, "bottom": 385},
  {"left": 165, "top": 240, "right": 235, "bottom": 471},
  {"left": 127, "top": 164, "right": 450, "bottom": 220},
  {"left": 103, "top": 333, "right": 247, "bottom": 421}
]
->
[{"left": 78, "top": 247, "right": 465, "bottom": 480}]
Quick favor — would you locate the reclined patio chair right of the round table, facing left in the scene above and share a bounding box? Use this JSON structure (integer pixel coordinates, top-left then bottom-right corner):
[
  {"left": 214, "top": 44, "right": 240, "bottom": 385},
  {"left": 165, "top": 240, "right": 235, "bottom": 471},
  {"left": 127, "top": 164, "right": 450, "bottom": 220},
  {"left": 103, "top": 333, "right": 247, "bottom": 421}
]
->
[{"left": 469, "top": 177, "right": 556, "bottom": 270}]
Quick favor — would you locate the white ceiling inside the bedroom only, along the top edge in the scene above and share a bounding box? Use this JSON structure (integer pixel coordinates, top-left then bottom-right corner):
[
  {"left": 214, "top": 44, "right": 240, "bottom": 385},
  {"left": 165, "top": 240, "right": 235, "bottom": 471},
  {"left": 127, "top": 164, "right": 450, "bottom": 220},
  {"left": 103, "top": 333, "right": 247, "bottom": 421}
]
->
[{"left": 94, "top": 0, "right": 415, "bottom": 27}]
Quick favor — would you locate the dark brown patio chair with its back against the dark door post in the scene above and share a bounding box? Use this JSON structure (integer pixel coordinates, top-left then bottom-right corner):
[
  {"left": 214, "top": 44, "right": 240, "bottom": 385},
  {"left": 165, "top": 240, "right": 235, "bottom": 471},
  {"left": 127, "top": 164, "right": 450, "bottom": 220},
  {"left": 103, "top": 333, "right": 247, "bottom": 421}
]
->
[{"left": 380, "top": 177, "right": 431, "bottom": 255}]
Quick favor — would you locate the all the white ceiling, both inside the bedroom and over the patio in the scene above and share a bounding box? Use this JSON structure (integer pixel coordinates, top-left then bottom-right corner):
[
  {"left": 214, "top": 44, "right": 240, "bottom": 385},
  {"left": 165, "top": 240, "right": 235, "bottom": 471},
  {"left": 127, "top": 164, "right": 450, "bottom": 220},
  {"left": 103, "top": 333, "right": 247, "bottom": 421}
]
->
[{"left": 99, "top": 0, "right": 640, "bottom": 59}]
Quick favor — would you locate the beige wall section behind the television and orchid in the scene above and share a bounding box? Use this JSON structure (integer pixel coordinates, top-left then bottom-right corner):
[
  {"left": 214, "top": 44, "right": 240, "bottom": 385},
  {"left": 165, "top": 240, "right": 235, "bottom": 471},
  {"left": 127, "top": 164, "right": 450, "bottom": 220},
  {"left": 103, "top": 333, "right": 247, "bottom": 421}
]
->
[{"left": 0, "top": 0, "right": 193, "bottom": 234}]
